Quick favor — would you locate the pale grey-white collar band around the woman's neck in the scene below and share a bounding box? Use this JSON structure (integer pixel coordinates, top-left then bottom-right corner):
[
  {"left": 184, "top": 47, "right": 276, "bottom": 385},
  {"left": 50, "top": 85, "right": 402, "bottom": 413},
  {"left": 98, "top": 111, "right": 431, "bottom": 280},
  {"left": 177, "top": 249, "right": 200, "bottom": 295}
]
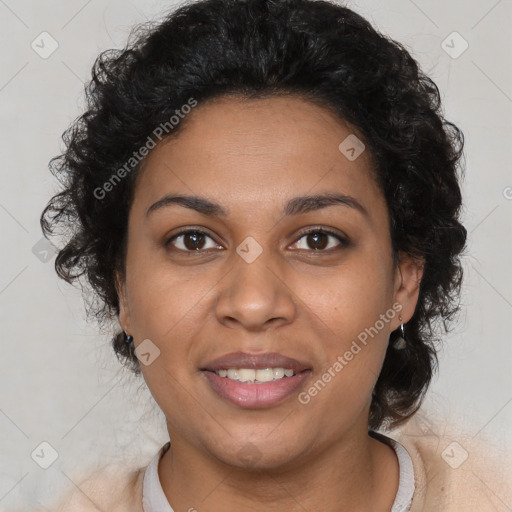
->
[{"left": 142, "top": 432, "right": 414, "bottom": 512}]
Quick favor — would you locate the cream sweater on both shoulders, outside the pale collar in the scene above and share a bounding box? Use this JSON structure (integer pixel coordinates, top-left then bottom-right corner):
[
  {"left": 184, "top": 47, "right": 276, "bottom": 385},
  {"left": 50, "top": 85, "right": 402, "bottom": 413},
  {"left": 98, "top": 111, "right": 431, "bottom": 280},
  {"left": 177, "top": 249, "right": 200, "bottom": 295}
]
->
[{"left": 29, "top": 415, "right": 512, "bottom": 512}]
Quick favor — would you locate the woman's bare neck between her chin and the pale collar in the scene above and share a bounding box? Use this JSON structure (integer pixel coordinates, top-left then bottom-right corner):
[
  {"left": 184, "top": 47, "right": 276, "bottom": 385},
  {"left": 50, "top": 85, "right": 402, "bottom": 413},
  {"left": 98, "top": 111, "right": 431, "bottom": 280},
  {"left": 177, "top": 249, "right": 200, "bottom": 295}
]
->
[{"left": 159, "top": 422, "right": 399, "bottom": 512}]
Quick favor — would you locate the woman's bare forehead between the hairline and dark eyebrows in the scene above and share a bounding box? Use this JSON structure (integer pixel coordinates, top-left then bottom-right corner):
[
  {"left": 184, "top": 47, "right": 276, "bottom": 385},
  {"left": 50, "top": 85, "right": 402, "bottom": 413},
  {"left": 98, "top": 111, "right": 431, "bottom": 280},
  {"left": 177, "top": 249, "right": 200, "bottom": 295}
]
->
[{"left": 131, "top": 96, "right": 385, "bottom": 221}]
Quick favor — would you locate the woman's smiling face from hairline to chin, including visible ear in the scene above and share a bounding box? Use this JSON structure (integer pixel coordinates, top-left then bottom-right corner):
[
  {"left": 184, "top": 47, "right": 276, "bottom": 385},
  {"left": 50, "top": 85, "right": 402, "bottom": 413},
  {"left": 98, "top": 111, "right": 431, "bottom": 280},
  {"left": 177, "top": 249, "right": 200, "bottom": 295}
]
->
[{"left": 120, "top": 97, "right": 421, "bottom": 468}]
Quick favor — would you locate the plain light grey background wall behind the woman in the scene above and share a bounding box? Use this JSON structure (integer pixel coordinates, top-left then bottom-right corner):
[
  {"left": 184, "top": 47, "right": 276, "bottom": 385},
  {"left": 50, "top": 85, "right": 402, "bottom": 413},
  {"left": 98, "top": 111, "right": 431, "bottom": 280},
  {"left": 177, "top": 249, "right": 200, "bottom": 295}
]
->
[{"left": 0, "top": 0, "right": 512, "bottom": 510}]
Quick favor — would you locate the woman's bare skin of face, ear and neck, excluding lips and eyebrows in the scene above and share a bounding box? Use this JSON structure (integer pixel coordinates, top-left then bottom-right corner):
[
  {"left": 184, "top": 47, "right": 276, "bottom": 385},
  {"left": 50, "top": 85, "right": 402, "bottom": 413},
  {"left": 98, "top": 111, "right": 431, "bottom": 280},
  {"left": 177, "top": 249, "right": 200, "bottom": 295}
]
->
[{"left": 118, "top": 96, "right": 422, "bottom": 512}]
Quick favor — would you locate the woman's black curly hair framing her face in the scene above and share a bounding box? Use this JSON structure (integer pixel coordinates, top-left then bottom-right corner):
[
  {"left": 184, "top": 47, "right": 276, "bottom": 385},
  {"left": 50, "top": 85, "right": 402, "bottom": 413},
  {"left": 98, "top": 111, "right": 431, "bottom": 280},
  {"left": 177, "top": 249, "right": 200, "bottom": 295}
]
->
[{"left": 41, "top": 0, "right": 467, "bottom": 430}]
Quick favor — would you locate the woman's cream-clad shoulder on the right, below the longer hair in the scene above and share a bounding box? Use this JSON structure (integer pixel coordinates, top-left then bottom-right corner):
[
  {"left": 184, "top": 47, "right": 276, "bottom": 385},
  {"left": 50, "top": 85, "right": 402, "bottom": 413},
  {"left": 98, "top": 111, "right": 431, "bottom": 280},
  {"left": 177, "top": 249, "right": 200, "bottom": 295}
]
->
[{"left": 388, "top": 413, "right": 512, "bottom": 512}]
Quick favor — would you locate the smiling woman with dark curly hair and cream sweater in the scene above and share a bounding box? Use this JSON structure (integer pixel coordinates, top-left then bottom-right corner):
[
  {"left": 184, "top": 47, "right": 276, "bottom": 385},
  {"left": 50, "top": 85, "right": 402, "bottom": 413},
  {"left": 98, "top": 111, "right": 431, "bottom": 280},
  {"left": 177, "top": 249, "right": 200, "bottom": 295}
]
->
[{"left": 37, "top": 0, "right": 507, "bottom": 512}]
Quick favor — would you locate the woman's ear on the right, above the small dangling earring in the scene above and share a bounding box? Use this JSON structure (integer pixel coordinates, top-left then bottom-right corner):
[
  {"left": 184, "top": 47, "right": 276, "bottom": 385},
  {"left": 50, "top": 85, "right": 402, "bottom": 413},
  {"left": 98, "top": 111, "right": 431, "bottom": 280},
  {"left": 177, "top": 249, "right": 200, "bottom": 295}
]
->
[{"left": 394, "top": 252, "right": 425, "bottom": 329}]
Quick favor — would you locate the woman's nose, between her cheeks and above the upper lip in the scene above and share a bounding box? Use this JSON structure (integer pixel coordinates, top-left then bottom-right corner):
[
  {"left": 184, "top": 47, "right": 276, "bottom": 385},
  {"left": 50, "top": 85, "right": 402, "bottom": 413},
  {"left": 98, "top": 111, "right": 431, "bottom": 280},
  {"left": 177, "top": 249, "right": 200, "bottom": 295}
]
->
[{"left": 215, "top": 250, "right": 297, "bottom": 332}]
